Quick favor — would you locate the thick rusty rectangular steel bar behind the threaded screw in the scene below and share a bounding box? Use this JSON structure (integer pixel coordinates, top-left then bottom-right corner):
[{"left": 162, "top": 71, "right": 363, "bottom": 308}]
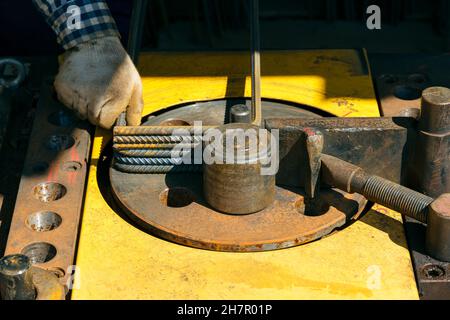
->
[{"left": 265, "top": 117, "right": 415, "bottom": 186}]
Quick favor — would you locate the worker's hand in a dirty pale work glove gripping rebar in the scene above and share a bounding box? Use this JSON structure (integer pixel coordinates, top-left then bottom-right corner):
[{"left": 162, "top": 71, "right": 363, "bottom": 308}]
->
[{"left": 54, "top": 37, "right": 143, "bottom": 129}]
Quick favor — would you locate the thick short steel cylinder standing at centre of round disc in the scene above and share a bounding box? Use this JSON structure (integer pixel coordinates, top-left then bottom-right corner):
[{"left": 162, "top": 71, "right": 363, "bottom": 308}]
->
[{"left": 203, "top": 123, "right": 275, "bottom": 214}]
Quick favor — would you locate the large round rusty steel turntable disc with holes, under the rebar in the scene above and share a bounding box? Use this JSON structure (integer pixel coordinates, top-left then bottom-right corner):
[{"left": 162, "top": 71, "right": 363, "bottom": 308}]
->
[{"left": 110, "top": 101, "right": 366, "bottom": 251}]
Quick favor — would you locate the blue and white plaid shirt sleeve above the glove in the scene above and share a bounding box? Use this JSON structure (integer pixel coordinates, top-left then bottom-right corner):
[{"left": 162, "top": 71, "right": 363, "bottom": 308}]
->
[{"left": 33, "top": 0, "right": 120, "bottom": 50}]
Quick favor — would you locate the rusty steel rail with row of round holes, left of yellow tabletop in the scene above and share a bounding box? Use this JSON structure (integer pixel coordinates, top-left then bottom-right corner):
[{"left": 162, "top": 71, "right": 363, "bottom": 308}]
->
[{"left": 5, "top": 81, "right": 90, "bottom": 292}]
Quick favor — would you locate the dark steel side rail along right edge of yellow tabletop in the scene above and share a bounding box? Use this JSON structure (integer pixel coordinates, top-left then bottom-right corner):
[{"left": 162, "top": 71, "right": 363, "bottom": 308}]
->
[{"left": 370, "top": 54, "right": 450, "bottom": 300}]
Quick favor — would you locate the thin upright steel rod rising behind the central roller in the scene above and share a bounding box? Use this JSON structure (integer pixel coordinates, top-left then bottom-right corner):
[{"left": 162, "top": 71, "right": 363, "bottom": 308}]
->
[{"left": 250, "top": 0, "right": 261, "bottom": 126}]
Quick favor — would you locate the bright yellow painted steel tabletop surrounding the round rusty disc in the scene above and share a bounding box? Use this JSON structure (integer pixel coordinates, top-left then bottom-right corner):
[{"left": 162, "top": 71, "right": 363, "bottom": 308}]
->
[{"left": 72, "top": 50, "right": 418, "bottom": 299}]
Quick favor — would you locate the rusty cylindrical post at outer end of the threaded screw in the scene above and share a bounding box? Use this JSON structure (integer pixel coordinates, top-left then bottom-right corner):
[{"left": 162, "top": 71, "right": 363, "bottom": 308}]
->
[{"left": 425, "top": 193, "right": 450, "bottom": 262}]
